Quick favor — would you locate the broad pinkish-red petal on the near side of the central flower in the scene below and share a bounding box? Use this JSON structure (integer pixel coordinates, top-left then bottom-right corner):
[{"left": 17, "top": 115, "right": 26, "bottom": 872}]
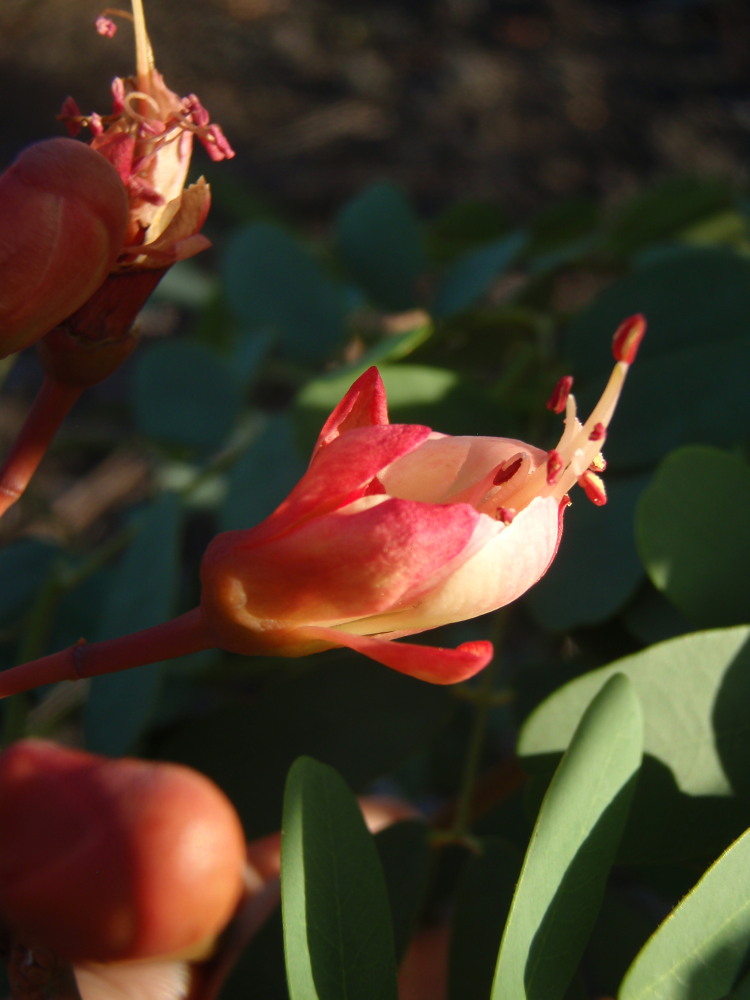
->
[{"left": 202, "top": 496, "right": 482, "bottom": 632}]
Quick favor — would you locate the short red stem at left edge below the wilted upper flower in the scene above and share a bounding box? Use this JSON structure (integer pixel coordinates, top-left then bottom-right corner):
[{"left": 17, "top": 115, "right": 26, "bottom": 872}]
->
[{"left": 0, "top": 375, "right": 83, "bottom": 517}]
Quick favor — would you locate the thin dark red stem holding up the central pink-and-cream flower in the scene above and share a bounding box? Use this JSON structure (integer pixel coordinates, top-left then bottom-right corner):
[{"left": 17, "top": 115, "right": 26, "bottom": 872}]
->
[{"left": 0, "top": 608, "right": 216, "bottom": 698}]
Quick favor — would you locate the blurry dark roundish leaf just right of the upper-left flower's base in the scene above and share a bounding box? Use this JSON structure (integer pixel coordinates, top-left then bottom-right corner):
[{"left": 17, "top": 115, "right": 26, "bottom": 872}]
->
[{"left": 133, "top": 340, "right": 242, "bottom": 452}]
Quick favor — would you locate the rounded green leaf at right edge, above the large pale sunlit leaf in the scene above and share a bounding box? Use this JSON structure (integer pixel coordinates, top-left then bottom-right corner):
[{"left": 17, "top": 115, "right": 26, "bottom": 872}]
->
[{"left": 636, "top": 447, "right": 750, "bottom": 627}]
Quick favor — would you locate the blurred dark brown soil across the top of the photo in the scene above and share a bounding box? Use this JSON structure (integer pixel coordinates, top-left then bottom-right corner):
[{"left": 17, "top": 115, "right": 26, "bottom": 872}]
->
[{"left": 0, "top": 0, "right": 750, "bottom": 222}]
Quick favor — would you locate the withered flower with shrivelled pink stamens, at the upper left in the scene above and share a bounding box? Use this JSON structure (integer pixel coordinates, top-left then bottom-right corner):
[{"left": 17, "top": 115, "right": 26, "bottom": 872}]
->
[{"left": 61, "top": 0, "right": 234, "bottom": 269}]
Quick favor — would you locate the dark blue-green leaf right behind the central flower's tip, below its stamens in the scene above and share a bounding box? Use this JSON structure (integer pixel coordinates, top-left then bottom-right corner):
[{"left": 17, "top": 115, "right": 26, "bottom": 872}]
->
[{"left": 526, "top": 476, "right": 648, "bottom": 631}]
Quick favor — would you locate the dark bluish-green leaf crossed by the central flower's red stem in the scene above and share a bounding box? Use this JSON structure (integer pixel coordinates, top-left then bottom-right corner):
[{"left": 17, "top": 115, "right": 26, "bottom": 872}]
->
[{"left": 85, "top": 493, "right": 181, "bottom": 756}]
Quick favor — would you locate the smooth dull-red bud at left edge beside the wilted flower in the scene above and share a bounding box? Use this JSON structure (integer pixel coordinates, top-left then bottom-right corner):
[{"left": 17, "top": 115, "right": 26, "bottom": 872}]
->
[{"left": 0, "top": 139, "right": 128, "bottom": 357}]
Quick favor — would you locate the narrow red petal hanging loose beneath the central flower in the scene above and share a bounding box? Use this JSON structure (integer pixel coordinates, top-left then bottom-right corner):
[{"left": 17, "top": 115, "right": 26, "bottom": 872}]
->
[{"left": 296, "top": 626, "right": 493, "bottom": 684}]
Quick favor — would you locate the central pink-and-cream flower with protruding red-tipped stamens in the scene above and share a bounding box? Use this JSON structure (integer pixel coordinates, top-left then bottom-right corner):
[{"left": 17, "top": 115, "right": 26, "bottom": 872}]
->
[{"left": 201, "top": 317, "right": 645, "bottom": 683}]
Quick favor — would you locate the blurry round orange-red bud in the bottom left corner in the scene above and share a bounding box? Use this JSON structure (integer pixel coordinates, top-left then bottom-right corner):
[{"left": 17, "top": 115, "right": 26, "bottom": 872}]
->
[{"left": 0, "top": 740, "right": 245, "bottom": 962}]
